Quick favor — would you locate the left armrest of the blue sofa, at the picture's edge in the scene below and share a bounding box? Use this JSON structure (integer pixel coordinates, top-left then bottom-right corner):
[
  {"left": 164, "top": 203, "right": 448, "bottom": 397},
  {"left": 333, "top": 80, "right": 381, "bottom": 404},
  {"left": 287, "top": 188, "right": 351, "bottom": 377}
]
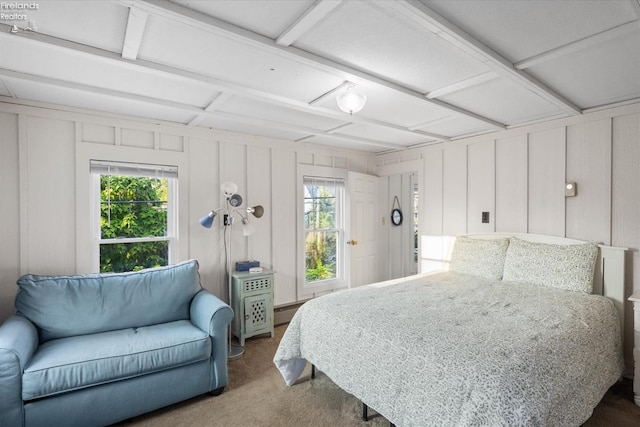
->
[{"left": 0, "top": 316, "right": 38, "bottom": 426}]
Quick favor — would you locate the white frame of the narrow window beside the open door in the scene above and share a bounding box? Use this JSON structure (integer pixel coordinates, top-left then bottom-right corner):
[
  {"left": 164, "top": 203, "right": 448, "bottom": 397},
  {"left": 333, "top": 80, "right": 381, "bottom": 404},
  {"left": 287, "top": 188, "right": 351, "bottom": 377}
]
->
[{"left": 297, "top": 165, "right": 348, "bottom": 299}]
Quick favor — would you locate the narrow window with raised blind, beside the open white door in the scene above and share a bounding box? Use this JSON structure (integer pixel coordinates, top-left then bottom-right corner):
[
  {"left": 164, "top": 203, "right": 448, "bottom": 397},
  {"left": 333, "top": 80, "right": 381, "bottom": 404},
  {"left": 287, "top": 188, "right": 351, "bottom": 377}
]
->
[{"left": 303, "top": 176, "right": 344, "bottom": 285}]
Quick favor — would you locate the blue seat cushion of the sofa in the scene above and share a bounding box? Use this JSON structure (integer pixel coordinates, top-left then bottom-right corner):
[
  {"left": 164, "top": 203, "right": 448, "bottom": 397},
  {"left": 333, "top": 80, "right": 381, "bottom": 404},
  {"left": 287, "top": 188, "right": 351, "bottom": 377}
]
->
[{"left": 22, "top": 320, "right": 211, "bottom": 400}]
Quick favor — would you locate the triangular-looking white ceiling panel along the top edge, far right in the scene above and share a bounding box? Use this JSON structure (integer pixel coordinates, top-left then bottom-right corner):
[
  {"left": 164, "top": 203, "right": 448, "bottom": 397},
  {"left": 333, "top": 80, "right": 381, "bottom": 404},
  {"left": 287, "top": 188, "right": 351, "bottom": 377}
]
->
[{"left": 426, "top": 0, "right": 638, "bottom": 62}]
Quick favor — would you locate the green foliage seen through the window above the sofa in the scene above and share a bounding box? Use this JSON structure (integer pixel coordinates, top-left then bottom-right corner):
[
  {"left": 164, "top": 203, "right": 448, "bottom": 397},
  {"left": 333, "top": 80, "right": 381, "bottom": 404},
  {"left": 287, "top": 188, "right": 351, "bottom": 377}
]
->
[{"left": 100, "top": 175, "right": 169, "bottom": 272}]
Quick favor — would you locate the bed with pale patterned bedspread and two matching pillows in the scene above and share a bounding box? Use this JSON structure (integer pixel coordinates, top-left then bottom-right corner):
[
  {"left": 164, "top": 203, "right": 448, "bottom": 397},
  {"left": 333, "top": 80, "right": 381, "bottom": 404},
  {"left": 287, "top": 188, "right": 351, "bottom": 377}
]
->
[{"left": 274, "top": 234, "right": 624, "bottom": 426}]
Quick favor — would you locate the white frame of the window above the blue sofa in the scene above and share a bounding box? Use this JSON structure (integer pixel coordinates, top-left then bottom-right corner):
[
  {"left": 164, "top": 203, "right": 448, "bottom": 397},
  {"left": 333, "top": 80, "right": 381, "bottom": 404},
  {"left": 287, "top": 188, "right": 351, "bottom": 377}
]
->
[{"left": 90, "top": 160, "right": 179, "bottom": 273}]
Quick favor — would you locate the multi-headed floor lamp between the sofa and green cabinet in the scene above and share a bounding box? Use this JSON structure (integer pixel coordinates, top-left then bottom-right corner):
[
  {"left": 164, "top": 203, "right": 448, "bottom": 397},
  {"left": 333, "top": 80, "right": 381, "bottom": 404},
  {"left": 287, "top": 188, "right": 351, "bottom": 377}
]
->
[{"left": 200, "top": 182, "right": 264, "bottom": 360}]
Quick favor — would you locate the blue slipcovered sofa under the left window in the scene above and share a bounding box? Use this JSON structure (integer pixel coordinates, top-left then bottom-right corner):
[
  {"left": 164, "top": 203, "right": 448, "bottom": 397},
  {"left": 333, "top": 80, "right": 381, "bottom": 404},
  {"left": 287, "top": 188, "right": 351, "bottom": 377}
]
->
[{"left": 0, "top": 260, "right": 233, "bottom": 427}]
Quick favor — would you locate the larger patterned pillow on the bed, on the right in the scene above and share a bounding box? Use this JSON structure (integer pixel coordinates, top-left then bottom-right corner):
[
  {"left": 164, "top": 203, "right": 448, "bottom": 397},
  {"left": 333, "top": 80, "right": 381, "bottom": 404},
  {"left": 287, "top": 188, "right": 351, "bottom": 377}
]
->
[{"left": 502, "top": 237, "right": 598, "bottom": 294}]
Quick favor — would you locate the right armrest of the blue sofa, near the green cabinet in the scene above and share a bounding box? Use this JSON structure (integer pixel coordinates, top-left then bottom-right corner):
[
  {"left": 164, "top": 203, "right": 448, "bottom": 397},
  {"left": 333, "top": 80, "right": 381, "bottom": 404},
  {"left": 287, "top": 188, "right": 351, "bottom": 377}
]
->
[{"left": 190, "top": 289, "right": 233, "bottom": 391}]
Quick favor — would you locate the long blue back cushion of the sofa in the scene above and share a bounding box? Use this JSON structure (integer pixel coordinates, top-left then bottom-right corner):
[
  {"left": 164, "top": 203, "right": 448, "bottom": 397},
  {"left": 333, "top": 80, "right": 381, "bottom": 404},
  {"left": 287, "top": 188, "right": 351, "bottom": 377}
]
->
[{"left": 16, "top": 260, "right": 201, "bottom": 342}]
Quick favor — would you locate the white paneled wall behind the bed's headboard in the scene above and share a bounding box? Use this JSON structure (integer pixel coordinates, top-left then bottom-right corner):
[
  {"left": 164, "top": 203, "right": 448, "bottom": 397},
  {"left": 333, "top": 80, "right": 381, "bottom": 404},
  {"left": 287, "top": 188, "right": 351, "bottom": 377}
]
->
[{"left": 378, "top": 103, "right": 640, "bottom": 372}]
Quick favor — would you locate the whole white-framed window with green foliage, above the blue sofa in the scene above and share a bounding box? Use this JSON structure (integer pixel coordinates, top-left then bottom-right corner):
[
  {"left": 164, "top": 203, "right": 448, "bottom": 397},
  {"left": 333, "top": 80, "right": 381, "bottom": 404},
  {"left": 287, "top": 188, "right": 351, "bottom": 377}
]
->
[{"left": 91, "top": 160, "right": 178, "bottom": 273}]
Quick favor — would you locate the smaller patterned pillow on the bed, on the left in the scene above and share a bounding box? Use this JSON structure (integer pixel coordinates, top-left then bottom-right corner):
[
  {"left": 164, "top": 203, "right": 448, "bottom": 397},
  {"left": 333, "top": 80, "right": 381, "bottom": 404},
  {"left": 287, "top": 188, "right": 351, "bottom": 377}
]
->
[{"left": 449, "top": 236, "right": 509, "bottom": 280}]
